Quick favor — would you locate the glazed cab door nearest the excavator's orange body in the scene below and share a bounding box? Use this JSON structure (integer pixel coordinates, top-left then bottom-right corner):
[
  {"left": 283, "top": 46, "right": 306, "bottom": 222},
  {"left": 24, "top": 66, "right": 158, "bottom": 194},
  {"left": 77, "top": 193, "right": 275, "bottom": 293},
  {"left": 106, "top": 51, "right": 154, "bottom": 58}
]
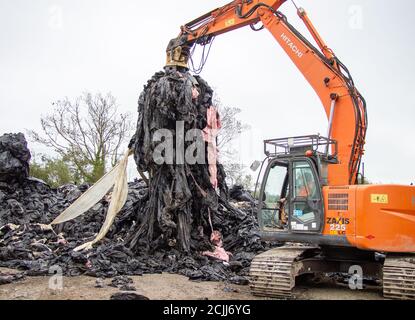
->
[{"left": 289, "top": 158, "right": 324, "bottom": 233}]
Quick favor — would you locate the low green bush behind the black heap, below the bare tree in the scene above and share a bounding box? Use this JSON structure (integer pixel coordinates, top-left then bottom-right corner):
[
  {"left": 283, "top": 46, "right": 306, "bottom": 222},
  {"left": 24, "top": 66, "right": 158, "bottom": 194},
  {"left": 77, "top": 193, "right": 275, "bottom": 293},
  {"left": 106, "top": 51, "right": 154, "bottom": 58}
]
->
[{"left": 30, "top": 156, "right": 78, "bottom": 188}]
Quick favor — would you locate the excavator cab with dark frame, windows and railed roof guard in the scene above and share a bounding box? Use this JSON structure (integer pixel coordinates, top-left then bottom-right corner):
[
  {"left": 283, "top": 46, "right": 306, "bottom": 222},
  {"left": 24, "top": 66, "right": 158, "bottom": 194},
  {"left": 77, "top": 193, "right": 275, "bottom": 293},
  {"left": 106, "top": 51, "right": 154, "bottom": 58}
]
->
[{"left": 258, "top": 136, "right": 337, "bottom": 240}]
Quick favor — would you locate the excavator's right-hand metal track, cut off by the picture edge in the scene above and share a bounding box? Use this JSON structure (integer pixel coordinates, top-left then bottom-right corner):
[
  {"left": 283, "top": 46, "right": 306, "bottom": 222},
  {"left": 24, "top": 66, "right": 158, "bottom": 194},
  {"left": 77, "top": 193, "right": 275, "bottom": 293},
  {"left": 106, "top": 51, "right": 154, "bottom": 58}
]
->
[{"left": 383, "top": 255, "right": 415, "bottom": 300}]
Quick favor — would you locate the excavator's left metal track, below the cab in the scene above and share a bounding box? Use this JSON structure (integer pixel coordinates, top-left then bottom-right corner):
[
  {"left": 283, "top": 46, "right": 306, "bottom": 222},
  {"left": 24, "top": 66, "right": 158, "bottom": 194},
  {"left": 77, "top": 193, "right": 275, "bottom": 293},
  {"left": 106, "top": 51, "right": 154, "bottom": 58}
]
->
[{"left": 250, "top": 246, "right": 315, "bottom": 299}]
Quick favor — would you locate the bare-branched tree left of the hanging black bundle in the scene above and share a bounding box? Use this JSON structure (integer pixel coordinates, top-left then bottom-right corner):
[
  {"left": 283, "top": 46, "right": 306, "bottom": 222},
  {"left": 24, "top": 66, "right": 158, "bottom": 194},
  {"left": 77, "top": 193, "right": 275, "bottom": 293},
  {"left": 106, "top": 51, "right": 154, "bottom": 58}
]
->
[{"left": 29, "top": 93, "right": 132, "bottom": 183}]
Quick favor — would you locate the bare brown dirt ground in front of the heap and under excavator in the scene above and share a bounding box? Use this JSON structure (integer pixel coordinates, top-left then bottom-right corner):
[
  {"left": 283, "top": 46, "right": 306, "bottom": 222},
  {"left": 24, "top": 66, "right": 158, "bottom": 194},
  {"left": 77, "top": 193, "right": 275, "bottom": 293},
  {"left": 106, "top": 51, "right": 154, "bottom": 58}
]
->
[{"left": 0, "top": 268, "right": 382, "bottom": 300}]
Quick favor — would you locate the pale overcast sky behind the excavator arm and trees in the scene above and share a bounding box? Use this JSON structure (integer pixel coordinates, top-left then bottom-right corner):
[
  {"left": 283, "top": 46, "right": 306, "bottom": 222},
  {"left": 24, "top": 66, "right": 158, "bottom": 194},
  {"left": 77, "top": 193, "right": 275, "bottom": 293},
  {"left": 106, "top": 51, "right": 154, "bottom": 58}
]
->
[{"left": 0, "top": 0, "right": 415, "bottom": 184}]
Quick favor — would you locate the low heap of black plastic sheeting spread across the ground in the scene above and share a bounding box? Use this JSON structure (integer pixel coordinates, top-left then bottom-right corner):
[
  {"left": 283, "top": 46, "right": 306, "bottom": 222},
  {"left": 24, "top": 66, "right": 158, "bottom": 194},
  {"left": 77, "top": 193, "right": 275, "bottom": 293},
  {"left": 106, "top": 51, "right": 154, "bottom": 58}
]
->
[{"left": 0, "top": 176, "right": 269, "bottom": 284}]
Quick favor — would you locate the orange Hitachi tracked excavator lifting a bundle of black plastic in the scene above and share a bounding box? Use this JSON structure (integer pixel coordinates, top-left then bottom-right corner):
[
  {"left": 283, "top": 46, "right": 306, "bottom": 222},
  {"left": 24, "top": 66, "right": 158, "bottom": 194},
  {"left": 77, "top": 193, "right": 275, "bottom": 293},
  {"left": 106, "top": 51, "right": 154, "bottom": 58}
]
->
[{"left": 167, "top": 0, "right": 415, "bottom": 299}]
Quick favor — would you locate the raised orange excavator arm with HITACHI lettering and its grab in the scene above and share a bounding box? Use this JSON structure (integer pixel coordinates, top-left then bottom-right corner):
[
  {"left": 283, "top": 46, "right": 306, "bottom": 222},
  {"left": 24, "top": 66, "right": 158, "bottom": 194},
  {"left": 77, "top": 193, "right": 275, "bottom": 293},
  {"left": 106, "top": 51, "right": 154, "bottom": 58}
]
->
[{"left": 167, "top": 0, "right": 367, "bottom": 186}]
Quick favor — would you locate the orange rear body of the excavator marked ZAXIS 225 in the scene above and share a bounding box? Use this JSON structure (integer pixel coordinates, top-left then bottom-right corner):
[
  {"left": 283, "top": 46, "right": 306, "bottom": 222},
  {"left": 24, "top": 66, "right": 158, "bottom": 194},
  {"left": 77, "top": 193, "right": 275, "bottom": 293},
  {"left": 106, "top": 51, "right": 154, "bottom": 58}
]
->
[{"left": 323, "top": 185, "right": 415, "bottom": 252}]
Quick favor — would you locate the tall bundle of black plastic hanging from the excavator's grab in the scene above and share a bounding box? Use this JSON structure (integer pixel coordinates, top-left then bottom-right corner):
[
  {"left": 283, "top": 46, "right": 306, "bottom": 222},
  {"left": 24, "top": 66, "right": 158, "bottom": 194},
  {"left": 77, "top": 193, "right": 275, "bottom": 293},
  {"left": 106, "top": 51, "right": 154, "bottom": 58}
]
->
[{"left": 130, "top": 68, "right": 227, "bottom": 252}]
